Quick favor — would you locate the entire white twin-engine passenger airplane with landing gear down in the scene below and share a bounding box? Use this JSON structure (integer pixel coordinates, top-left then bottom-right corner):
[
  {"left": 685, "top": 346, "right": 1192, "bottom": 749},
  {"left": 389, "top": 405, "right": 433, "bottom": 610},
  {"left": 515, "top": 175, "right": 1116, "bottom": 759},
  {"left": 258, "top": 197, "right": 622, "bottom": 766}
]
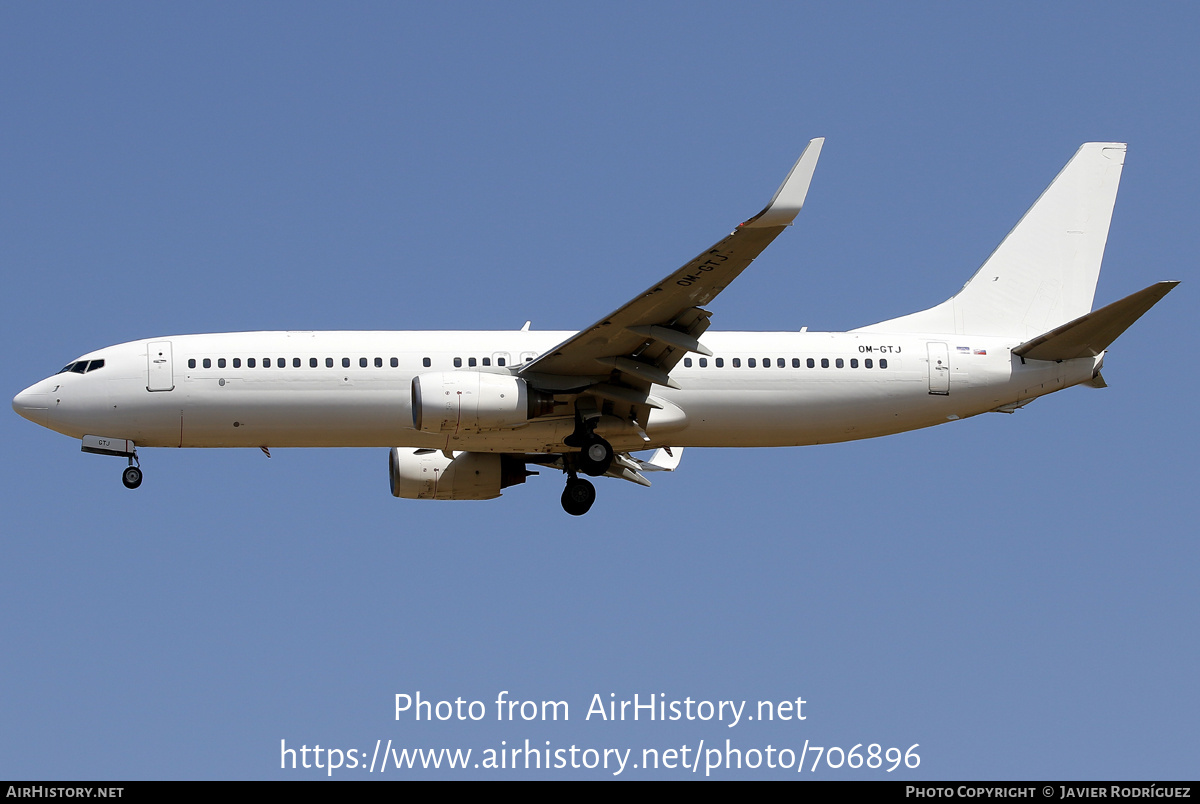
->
[{"left": 12, "top": 139, "right": 1177, "bottom": 516}]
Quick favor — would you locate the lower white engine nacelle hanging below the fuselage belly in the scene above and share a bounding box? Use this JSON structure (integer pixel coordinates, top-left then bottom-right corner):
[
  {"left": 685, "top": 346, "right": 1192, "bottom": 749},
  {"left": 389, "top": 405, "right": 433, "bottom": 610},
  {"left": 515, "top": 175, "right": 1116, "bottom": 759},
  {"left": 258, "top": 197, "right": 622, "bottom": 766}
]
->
[{"left": 388, "top": 446, "right": 528, "bottom": 499}]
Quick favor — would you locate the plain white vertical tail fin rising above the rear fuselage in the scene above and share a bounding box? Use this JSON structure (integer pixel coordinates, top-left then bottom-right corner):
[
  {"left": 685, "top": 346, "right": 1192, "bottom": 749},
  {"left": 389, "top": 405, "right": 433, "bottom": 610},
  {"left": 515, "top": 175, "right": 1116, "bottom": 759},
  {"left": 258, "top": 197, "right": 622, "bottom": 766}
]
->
[{"left": 860, "top": 143, "right": 1126, "bottom": 340}]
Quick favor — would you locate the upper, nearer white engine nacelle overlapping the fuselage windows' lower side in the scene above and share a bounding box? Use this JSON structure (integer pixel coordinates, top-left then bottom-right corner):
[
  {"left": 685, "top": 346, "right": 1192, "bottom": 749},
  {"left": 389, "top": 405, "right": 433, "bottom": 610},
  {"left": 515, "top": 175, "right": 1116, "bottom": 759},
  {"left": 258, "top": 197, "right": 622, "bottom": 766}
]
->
[{"left": 413, "top": 371, "right": 554, "bottom": 433}]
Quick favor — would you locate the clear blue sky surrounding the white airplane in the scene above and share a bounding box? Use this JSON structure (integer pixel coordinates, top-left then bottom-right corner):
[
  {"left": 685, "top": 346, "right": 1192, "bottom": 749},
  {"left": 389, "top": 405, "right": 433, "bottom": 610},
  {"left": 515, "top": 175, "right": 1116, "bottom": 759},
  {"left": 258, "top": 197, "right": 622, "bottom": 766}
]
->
[{"left": 0, "top": 4, "right": 1200, "bottom": 779}]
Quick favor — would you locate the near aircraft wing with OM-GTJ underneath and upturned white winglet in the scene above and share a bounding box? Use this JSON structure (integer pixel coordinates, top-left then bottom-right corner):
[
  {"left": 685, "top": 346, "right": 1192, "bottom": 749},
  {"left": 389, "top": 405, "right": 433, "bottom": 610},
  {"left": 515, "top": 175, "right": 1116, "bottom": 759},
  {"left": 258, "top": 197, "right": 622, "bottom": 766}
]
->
[{"left": 520, "top": 138, "right": 824, "bottom": 396}]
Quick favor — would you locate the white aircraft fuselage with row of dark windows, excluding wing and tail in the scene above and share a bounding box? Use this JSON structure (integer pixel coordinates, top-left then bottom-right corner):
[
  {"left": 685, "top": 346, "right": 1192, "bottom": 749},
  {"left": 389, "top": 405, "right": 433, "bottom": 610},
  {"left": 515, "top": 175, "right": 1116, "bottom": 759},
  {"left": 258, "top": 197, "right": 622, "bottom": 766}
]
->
[{"left": 13, "top": 331, "right": 1100, "bottom": 452}]
